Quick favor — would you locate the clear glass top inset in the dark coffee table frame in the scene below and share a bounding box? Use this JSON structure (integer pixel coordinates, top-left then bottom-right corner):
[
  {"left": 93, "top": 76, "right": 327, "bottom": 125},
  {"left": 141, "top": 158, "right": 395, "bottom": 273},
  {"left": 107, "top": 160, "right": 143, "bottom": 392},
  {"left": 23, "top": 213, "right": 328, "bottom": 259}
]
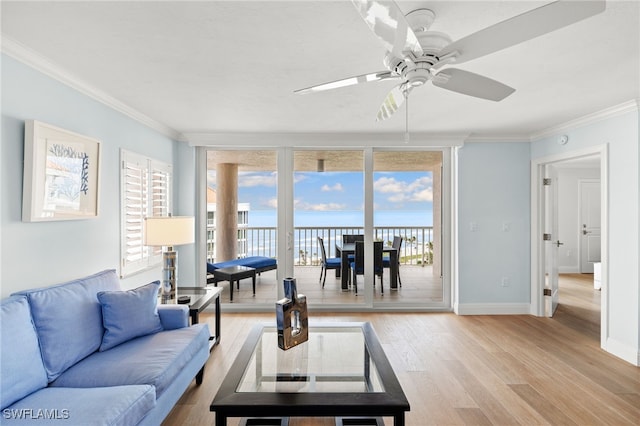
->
[{"left": 236, "top": 326, "right": 384, "bottom": 393}]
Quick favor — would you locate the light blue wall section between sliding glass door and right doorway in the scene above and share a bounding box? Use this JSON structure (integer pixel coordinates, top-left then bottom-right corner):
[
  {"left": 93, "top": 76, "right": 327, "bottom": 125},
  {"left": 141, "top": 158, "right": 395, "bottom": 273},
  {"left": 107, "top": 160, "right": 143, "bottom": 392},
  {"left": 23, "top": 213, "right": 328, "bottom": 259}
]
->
[{"left": 458, "top": 142, "right": 531, "bottom": 305}]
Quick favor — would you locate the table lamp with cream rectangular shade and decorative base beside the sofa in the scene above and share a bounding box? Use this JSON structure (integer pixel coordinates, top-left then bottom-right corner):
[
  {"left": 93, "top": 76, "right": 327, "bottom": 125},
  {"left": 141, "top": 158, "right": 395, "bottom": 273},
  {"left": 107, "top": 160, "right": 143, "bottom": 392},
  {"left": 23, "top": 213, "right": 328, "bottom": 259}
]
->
[{"left": 144, "top": 216, "right": 194, "bottom": 303}]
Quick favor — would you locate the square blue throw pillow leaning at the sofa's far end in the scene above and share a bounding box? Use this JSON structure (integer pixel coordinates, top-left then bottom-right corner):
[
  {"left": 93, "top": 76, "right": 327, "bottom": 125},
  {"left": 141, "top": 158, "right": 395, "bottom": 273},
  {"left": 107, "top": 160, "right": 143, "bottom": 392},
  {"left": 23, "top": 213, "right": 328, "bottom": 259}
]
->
[{"left": 98, "top": 281, "right": 162, "bottom": 352}]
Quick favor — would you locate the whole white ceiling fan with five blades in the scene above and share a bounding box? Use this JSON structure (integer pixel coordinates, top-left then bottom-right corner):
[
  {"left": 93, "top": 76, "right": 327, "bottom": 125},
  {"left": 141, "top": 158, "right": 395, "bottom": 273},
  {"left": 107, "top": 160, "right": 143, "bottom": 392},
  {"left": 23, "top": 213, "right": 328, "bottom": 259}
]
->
[{"left": 295, "top": 0, "right": 605, "bottom": 121}]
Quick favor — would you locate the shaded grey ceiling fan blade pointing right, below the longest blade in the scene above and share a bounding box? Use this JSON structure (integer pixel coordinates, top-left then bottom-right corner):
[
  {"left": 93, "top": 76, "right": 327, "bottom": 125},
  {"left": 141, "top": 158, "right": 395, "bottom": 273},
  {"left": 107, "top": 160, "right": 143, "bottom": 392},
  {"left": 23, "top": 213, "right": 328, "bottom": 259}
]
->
[{"left": 431, "top": 68, "right": 516, "bottom": 102}]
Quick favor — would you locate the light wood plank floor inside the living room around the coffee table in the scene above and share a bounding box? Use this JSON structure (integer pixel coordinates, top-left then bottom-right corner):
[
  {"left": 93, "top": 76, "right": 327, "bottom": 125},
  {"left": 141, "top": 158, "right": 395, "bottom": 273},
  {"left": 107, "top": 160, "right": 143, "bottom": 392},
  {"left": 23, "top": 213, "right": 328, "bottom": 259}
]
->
[{"left": 164, "top": 274, "right": 640, "bottom": 426}]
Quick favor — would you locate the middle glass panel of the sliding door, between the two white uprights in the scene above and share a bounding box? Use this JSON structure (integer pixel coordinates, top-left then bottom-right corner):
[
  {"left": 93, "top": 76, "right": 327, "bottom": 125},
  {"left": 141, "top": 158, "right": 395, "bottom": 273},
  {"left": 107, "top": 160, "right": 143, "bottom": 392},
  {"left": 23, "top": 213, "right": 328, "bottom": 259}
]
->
[{"left": 292, "top": 150, "right": 365, "bottom": 308}]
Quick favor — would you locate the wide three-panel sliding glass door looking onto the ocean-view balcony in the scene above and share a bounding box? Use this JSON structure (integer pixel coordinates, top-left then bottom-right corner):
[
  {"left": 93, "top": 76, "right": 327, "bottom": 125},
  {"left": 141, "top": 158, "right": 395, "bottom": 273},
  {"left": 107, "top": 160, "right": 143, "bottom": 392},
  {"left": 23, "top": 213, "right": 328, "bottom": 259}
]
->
[{"left": 206, "top": 147, "right": 453, "bottom": 311}]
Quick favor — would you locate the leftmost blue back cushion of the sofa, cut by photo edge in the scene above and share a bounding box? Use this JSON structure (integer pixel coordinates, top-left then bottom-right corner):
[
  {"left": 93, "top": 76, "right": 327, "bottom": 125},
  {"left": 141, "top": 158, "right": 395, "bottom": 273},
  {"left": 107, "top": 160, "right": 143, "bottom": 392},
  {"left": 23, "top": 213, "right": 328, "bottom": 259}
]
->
[{"left": 0, "top": 296, "right": 47, "bottom": 409}]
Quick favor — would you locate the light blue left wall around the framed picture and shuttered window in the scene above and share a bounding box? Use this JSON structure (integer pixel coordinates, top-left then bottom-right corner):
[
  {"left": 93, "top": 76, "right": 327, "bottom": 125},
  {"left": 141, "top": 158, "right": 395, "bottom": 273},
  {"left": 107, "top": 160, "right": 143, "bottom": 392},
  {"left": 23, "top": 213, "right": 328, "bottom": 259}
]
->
[{"left": 0, "top": 55, "right": 182, "bottom": 297}]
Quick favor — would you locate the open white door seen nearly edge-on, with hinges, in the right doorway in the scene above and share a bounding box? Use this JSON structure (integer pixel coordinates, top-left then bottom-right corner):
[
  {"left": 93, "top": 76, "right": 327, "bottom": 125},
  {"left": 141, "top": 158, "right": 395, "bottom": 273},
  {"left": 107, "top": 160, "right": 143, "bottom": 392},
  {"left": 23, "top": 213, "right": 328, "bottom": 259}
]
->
[{"left": 542, "top": 165, "right": 562, "bottom": 317}]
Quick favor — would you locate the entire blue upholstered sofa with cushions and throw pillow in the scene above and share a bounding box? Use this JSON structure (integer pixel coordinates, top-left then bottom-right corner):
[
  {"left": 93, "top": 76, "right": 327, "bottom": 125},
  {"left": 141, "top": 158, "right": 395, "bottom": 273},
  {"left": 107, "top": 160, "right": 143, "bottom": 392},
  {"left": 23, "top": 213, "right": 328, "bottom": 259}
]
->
[{"left": 0, "top": 270, "right": 210, "bottom": 426}]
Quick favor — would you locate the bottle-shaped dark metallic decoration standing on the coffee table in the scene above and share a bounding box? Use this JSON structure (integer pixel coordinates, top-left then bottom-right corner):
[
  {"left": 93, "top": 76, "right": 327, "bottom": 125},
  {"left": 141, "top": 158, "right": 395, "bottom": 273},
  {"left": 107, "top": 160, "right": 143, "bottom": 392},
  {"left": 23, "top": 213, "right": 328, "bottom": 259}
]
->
[{"left": 276, "top": 278, "right": 309, "bottom": 350}]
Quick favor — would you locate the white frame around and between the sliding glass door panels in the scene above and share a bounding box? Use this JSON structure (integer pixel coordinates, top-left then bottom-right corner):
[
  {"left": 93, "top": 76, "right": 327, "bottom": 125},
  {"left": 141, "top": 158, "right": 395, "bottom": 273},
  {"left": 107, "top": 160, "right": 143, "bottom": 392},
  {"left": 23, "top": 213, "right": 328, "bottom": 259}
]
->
[{"left": 195, "top": 143, "right": 459, "bottom": 312}]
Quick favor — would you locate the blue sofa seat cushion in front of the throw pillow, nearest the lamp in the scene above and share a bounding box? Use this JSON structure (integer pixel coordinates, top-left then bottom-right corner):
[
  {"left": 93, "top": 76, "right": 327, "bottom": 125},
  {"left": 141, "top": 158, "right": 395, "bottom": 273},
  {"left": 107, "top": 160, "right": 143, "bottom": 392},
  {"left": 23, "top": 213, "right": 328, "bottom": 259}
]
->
[{"left": 51, "top": 324, "right": 210, "bottom": 398}]
